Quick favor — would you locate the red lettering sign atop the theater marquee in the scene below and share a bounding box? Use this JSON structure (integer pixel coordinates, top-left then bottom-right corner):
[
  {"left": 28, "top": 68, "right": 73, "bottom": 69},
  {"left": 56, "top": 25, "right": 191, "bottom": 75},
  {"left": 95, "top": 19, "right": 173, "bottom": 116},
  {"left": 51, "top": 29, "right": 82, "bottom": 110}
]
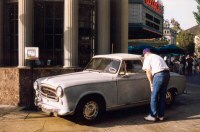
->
[{"left": 145, "top": 0, "right": 163, "bottom": 14}]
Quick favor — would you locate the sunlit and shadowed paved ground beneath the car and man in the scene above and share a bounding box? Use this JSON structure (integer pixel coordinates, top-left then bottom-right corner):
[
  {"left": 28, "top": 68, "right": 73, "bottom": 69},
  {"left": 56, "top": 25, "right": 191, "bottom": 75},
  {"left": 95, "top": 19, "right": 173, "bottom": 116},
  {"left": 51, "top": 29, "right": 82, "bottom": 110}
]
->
[{"left": 0, "top": 75, "right": 200, "bottom": 132}]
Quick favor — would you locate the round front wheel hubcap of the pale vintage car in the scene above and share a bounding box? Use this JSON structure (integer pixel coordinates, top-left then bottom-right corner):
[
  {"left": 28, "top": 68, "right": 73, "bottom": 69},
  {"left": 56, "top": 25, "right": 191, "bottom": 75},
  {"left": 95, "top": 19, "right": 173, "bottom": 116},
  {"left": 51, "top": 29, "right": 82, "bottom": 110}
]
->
[{"left": 83, "top": 101, "right": 99, "bottom": 120}]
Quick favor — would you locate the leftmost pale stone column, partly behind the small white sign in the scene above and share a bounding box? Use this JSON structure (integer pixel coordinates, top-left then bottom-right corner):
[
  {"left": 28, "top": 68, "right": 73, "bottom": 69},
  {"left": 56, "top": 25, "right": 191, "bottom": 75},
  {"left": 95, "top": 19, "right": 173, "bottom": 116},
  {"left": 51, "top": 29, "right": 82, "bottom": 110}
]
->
[{"left": 18, "top": 0, "right": 33, "bottom": 68}]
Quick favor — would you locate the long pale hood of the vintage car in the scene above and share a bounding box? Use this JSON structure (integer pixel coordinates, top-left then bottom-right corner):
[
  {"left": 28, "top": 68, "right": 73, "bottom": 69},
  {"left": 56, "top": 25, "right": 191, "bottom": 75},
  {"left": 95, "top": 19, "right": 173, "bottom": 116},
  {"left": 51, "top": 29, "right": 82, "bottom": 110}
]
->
[{"left": 41, "top": 71, "right": 116, "bottom": 88}]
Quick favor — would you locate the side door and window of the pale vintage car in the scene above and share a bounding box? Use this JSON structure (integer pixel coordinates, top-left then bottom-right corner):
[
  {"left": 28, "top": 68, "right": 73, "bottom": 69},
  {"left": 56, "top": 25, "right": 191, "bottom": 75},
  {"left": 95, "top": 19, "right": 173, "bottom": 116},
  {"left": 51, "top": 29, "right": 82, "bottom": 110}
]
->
[{"left": 117, "top": 60, "right": 151, "bottom": 105}]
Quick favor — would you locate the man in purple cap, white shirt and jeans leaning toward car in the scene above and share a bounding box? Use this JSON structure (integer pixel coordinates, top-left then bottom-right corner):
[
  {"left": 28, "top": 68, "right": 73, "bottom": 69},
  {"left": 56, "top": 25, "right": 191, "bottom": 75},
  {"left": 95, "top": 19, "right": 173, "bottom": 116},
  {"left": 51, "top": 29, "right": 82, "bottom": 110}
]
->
[{"left": 142, "top": 48, "right": 170, "bottom": 121}]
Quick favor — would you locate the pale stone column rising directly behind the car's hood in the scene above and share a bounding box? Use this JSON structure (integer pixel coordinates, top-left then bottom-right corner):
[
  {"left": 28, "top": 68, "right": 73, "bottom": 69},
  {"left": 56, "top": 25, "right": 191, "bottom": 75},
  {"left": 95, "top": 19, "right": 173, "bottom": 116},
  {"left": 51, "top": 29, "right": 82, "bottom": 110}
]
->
[{"left": 63, "top": 0, "right": 78, "bottom": 68}]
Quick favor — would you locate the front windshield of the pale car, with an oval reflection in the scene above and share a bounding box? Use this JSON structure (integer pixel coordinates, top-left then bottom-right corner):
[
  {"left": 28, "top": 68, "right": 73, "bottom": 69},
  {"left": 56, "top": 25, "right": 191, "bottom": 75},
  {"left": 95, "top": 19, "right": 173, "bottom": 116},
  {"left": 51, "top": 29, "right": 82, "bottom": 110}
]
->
[{"left": 85, "top": 58, "right": 120, "bottom": 74}]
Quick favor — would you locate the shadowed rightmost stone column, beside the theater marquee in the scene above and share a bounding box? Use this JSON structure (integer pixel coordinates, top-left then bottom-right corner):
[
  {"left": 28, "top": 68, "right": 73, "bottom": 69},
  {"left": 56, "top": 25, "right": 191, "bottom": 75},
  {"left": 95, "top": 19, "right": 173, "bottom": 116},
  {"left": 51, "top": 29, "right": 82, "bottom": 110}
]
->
[{"left": 111, "top": 0, "right": 129, "bottom": 53}]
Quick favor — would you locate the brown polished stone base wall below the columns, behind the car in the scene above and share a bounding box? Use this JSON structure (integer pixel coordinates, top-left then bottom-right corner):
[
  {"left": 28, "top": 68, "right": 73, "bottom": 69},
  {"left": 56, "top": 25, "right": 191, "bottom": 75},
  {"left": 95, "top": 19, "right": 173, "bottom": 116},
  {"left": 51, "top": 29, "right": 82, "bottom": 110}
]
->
[{"left": 0, "top": 68, "right": 81, "bottom": 106}]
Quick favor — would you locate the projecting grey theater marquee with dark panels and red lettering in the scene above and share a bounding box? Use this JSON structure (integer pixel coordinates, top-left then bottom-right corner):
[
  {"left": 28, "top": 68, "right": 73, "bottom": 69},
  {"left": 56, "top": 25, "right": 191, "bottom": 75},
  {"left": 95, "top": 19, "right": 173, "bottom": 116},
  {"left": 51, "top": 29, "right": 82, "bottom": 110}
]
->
[{"left": 129, "top": 0, "right": 163, "bottom": 39}]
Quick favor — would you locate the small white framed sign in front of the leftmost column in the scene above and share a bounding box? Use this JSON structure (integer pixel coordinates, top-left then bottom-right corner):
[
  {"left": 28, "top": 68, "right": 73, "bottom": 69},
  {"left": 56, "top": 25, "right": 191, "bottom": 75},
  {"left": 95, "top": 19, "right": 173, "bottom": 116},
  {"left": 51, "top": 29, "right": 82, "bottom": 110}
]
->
[{"left": 25, "top": 47, "right": 39, "bottom": 60}]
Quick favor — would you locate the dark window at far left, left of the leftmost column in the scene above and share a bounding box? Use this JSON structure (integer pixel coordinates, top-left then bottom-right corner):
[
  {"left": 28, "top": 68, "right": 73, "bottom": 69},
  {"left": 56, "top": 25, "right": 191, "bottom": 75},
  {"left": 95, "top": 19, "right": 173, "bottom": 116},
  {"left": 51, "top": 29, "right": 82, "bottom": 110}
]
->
[{"left": 3, "top": 2, "right": 18, "bottom": 66}]
